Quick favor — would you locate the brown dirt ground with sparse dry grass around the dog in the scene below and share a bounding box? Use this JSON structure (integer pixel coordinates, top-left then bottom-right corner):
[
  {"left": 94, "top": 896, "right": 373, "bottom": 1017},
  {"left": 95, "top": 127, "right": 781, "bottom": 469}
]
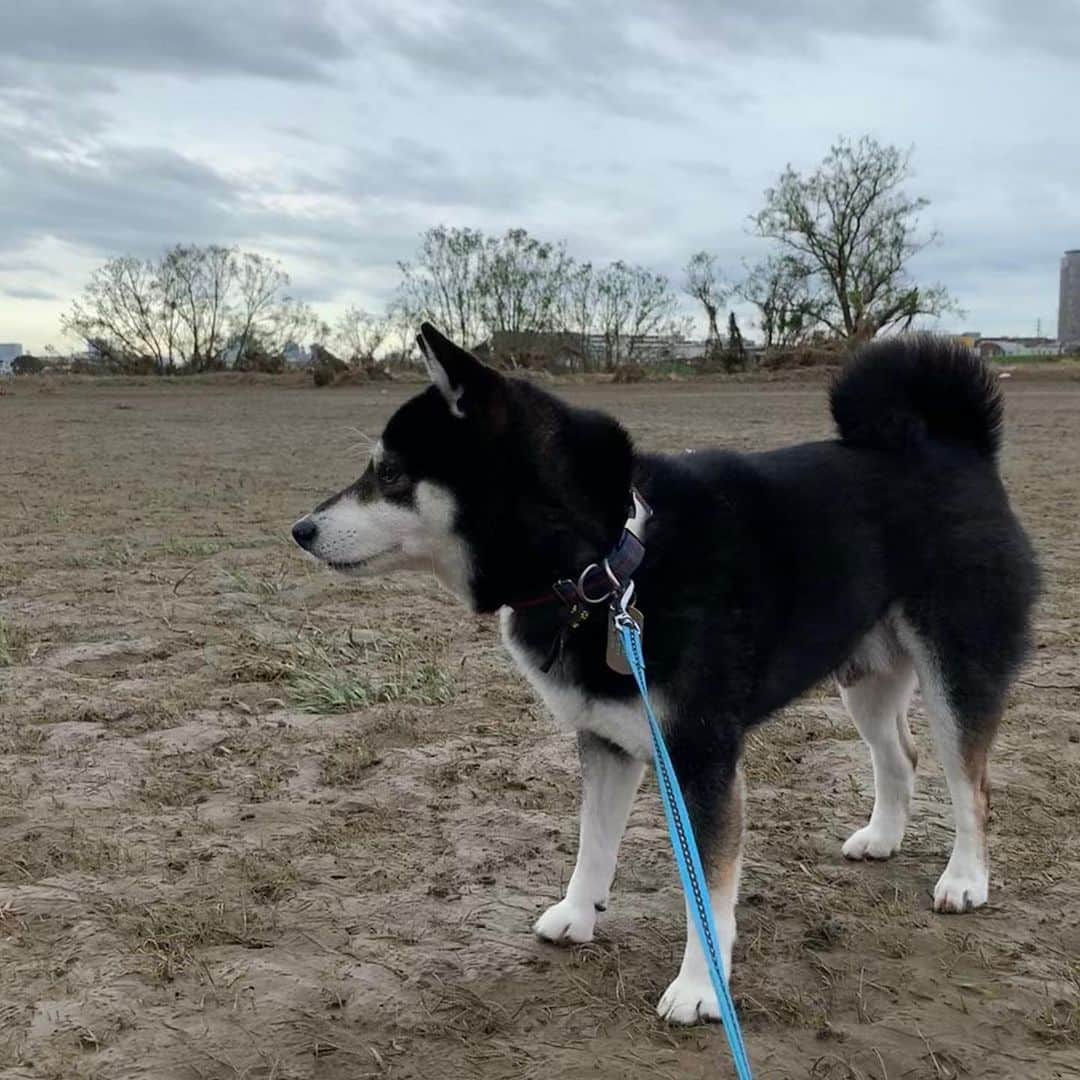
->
[{"left": 0, "top": 373, "right": 1080, "bottom": 1080}]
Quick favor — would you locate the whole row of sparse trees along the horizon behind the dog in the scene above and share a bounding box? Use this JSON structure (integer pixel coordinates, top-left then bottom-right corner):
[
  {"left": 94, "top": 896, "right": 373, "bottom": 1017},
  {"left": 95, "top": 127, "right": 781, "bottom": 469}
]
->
[{"left": 39, "top": 137, "right": 953, "bottom": 374}]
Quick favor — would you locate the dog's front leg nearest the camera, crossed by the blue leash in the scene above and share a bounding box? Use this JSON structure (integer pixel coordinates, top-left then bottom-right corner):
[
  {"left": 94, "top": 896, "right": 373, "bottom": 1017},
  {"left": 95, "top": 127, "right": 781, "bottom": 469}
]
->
[{"left": 657, "top": 754, "right": 744, "bottom": 1024}]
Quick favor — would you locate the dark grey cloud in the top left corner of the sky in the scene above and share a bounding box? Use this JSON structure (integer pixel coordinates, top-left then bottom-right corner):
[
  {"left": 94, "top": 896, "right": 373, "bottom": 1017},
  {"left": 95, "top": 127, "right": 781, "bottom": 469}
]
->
[{"left": 0, "top": 0, "right": 351, "bottom": 81}]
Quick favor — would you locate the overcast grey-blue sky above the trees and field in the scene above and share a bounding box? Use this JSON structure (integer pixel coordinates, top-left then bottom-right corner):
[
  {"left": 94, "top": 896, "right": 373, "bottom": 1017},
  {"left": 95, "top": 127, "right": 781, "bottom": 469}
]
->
[{"left": 0, "top": 0, "right": 1080, "bottom": 350}]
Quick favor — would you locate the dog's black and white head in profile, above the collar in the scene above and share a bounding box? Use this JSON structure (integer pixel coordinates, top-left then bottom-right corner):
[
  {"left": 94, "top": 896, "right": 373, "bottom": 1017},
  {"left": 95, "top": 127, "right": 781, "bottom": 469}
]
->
[{"left": 293, "top": 323, "right": 633, "bottom": 611}]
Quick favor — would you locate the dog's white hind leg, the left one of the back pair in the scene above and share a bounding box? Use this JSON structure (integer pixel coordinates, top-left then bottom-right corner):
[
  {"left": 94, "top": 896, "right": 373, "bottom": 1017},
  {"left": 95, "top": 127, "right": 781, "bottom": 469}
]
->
[{"left": 840, "top": 656, "right": 918, "bottom": 859}]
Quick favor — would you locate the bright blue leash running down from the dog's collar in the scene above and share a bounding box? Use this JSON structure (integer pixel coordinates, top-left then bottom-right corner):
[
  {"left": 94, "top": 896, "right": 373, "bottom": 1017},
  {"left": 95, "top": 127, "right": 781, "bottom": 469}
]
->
[{"left": 615, "top": 613, "right": 753, "bottom": 1080}]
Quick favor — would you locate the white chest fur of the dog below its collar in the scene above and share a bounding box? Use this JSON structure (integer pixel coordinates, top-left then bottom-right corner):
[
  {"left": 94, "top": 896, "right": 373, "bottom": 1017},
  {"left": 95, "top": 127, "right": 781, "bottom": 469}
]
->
[{"left": 500, "top": 608, "right": 663, "bottom": 761}]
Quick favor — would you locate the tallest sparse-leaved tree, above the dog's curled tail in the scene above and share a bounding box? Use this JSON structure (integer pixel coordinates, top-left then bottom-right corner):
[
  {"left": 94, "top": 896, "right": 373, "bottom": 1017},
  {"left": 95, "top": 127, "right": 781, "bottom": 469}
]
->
[{"left": 753, "top": 136, "right": 953, "bottom": 340}]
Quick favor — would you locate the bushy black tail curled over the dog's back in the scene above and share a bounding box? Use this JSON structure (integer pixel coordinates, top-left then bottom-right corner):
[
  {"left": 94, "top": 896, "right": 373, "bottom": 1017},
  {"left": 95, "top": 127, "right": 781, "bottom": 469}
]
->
[{"left": 829, "top": 334, "right": 1002, "bottom": 458}]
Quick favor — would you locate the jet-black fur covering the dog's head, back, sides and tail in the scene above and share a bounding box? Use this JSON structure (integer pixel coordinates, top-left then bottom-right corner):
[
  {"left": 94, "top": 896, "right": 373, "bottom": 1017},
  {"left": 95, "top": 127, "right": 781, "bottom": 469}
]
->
[{"left": 293, "top": 326, "right": 1038, "bottom": 1015}]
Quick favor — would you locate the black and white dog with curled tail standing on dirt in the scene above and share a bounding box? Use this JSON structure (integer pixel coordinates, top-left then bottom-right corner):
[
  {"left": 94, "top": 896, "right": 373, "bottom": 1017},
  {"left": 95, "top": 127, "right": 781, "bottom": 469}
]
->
[{"left": 293, "top": 324, "right": 1038, "bottom": 1024}]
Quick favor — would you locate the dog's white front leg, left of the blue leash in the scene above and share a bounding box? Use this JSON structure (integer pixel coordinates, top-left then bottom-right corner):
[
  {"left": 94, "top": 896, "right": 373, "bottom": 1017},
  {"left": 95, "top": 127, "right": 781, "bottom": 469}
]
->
[{"left": 532, "top": 731, "right": 645, "bottom": 944}]
